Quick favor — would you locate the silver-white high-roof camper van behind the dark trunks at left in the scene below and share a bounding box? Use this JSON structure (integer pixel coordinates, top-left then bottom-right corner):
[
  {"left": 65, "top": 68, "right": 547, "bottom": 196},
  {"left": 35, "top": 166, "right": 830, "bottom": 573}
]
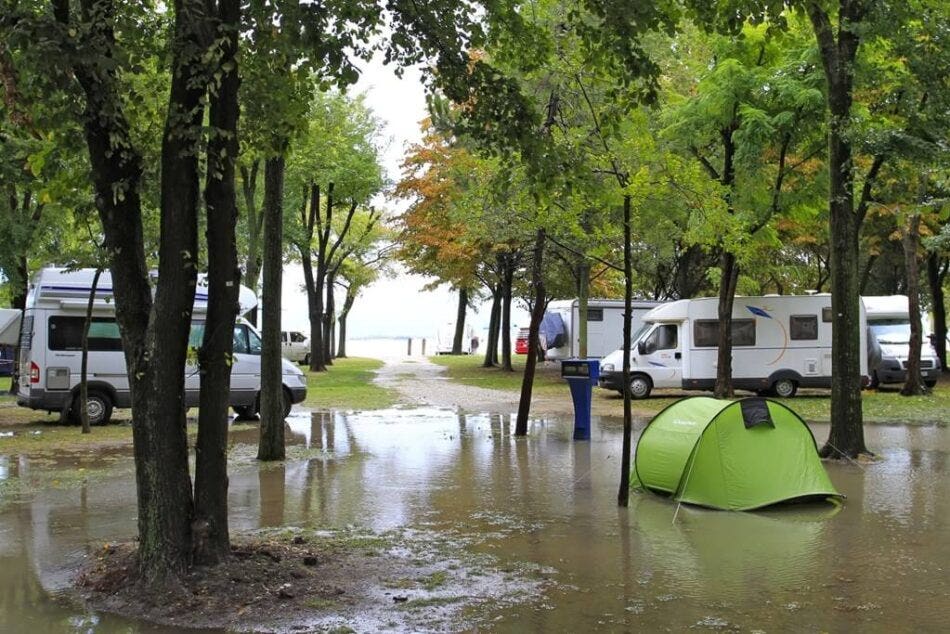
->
[{"left": 17, "top": 268, "right": 307, "bottom": 424}]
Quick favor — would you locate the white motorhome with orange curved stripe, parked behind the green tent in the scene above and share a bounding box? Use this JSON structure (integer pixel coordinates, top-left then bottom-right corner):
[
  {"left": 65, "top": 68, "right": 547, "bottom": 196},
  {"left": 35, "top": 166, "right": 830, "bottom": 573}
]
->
[{"left": 599, "top": 294, "right": 867, "bottom": 398}]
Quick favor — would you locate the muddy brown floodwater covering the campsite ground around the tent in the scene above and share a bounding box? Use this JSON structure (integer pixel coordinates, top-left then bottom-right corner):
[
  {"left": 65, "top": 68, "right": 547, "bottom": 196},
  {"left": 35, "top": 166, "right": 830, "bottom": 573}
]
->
[{"left": 0, "top": 409, "right": 950, "bottom": 632}]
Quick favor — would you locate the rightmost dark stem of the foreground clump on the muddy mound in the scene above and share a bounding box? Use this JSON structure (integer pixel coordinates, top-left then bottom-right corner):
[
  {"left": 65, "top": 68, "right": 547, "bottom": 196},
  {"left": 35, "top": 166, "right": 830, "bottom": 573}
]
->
[{"left": 193, "top": 0, "right": 241, "bottom": 563}]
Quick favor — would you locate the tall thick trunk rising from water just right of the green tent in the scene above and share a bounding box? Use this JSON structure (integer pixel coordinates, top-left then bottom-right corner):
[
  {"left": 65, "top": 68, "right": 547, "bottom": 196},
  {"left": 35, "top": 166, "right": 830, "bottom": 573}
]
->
[{"left": 806, "top": 0, "right": 868, "bottom": 458}]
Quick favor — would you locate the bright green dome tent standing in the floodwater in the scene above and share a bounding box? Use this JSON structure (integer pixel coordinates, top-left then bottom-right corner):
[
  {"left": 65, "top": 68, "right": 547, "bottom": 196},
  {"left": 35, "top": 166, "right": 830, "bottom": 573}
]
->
[{"left": 631, "top": 397, "right": 843, "bottom": 511}]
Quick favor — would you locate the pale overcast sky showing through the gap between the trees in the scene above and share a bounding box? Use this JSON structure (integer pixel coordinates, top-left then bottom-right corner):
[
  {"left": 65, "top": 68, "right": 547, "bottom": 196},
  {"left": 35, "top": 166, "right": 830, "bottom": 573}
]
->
[{"left": 283, "top": 55, "right": 528, "bottom": 338}]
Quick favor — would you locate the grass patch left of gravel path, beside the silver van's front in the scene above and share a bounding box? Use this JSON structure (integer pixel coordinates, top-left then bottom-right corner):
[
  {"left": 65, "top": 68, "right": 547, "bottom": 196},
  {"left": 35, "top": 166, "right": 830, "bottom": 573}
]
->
[{"left": 303, "top": 358, "right": 398, "bottom": 410}]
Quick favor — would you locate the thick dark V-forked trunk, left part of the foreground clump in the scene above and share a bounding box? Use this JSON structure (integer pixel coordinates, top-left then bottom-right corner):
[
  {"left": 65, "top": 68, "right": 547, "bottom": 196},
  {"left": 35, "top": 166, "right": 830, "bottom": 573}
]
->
[{"left": 53, "top": 0, "right": 208, "bottom": 583}]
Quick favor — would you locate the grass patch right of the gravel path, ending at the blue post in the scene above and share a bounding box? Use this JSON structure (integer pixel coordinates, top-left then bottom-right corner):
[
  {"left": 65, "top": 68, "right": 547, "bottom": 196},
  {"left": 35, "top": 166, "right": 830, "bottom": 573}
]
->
[{"left": 429, "top": 355, "right": 571, "bottom": 392}]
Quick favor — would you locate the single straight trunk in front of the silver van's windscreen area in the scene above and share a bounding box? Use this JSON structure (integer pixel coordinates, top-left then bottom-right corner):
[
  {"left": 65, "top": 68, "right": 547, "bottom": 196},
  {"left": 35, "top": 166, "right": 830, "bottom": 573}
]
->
[{"left": 257, "top": 153, "right": 288, "bottom": 460}]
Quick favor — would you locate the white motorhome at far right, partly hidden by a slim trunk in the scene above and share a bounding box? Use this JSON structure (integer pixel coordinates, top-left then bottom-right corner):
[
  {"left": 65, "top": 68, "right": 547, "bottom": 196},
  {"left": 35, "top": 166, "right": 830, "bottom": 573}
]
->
[{"left": 864, "top": 295, "right": 940, "bottom": 387}]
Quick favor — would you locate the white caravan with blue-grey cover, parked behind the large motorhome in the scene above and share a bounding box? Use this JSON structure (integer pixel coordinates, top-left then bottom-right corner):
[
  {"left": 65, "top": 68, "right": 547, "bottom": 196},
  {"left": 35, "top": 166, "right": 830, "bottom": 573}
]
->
[{"left": 541, "top": 299, "right": 662, "bottom": 360}]
